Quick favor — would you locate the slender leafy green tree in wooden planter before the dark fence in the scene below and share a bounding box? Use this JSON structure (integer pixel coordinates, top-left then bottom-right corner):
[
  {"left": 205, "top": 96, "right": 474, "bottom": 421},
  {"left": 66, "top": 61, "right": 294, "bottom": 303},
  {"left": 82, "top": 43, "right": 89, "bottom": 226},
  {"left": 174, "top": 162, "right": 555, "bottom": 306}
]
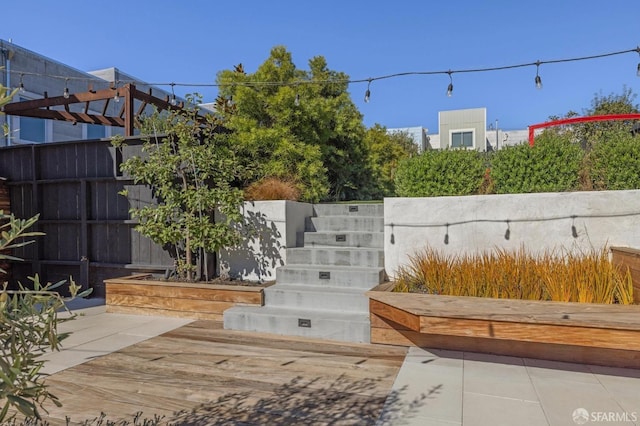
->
[{"left": 114, "top": 97, "right": 246, "bottom": 281}]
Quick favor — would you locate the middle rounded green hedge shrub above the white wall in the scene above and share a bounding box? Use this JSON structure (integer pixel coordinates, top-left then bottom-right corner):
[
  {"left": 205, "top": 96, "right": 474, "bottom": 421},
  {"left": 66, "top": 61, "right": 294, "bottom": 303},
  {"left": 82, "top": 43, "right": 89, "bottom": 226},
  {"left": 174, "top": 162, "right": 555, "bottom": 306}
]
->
[{"left": 491, "top": 132, "right": 583, "bottom": 194}]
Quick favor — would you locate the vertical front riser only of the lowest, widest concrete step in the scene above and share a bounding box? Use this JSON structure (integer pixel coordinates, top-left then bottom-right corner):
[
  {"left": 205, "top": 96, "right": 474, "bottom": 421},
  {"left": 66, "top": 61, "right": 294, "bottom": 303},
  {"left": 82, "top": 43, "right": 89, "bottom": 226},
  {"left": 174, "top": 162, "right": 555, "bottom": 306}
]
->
[{"left": 224, "top": 310, "right": 371, "bottom": 343}]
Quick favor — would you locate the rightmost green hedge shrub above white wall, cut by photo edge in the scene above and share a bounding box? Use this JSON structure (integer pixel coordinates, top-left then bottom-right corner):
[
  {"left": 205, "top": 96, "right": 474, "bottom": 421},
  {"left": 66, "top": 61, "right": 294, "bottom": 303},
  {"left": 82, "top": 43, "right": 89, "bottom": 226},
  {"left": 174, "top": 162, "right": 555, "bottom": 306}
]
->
[{"left": 590, "top": 132, "right": 640, "bottom": 190}]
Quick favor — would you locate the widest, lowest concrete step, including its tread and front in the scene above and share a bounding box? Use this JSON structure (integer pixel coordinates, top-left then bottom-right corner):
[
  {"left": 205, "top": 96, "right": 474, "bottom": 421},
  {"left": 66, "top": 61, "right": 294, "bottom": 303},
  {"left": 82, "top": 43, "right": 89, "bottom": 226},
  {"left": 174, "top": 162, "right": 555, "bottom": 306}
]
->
[{"left": 224, "top": 306, "right": 371, "bottom": 343}]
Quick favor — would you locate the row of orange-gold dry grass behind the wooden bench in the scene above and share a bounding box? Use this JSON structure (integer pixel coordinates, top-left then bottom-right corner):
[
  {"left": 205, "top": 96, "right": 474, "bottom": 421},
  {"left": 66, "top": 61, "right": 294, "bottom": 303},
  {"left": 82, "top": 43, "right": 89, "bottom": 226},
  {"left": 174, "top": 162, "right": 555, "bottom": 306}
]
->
[{"left": 395, "top": 248, "right": 633, "bottom": 305}]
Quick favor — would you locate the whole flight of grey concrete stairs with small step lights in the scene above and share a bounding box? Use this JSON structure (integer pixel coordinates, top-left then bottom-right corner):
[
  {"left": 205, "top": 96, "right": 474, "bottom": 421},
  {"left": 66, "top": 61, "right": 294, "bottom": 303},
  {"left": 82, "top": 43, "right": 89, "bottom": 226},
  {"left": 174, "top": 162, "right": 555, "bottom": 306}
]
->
[{"left": 224, "top": 204, "right": 386, "bottom": 342}]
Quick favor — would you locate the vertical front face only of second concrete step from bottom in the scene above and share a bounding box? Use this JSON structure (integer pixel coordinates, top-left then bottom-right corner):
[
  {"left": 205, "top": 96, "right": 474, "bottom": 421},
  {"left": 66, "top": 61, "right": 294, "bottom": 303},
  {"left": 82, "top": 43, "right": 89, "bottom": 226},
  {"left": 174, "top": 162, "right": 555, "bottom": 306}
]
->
[{"left": 264, "top": 285, "right": 369, "bottom": 314}]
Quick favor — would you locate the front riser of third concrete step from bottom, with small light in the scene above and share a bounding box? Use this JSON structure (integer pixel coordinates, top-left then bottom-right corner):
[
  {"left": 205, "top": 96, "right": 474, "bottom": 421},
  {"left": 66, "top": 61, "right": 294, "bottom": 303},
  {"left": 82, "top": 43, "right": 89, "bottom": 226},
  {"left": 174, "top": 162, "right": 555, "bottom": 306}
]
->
[{"left": 276, "top": 266, "right": 385, "bottom": 290}]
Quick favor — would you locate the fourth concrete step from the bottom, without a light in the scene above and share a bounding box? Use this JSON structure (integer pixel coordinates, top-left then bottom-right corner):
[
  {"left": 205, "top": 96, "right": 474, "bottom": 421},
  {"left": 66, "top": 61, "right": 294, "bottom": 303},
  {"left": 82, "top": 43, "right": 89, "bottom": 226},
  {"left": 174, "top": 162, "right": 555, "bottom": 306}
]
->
[{"left": 287, "top": 247, "right": 384, "bottom": 267}]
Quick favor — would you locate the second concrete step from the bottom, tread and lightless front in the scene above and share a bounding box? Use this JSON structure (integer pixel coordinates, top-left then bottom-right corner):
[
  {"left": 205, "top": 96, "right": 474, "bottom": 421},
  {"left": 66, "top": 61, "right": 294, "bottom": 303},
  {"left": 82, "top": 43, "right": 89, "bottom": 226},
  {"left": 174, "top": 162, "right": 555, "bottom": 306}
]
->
[{"left": 264, "top": 283, "right": 369, "bottom": 314}]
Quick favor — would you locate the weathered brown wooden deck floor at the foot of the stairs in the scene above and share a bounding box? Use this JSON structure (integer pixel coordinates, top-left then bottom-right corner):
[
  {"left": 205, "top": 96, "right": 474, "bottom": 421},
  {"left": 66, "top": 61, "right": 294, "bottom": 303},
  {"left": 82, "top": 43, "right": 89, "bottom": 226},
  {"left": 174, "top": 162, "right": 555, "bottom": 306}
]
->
[{"left": 36, "top": 321, "right": 407, "bottom": 425}]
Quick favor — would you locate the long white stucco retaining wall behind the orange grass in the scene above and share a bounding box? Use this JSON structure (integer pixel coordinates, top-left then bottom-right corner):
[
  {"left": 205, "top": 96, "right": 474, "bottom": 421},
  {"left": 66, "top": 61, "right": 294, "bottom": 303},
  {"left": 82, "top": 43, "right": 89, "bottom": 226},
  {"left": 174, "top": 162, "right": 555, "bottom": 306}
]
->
[{"left": 384, "top": 190, "right": 640, "bottom": 278}]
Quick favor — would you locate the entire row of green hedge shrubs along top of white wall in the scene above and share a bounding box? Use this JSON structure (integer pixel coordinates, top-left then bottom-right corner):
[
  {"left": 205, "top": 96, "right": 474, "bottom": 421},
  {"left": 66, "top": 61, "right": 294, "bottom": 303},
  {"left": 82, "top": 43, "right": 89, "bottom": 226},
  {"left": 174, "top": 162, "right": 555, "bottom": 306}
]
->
[{"left": 395, "top": 131, "right": 640, "bottom": 197}]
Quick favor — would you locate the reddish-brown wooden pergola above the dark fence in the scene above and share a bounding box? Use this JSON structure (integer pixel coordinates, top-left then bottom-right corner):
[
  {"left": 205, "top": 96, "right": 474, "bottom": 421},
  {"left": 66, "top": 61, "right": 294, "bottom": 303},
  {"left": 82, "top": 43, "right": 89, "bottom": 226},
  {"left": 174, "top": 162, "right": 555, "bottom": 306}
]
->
[{"left": 2, "top": 84, "right": 198, "bottom": 136}]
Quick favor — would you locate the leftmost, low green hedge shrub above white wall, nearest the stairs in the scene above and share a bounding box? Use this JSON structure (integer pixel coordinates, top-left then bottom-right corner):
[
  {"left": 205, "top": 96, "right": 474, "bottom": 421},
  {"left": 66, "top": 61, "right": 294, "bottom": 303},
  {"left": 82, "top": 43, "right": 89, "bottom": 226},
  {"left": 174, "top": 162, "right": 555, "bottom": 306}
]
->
[{"left": 395, "top": 149, "right": 485, "bottom": 197}]
